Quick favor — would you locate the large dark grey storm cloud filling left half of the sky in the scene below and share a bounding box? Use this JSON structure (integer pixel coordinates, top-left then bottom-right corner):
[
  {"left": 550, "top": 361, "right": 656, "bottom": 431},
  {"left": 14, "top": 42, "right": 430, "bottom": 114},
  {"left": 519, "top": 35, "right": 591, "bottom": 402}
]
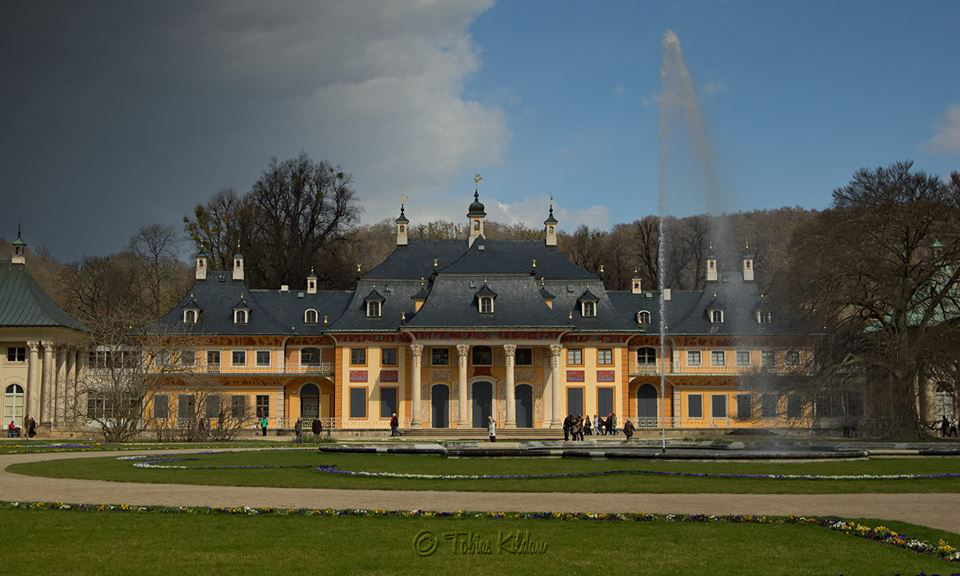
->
[{"left": 0, "top": 0, "right": 507, "bottom": 258}]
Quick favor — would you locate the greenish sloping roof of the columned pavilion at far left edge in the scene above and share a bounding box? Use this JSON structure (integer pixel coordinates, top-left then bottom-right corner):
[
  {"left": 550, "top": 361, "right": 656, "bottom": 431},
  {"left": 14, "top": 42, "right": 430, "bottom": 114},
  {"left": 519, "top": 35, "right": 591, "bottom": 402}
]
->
[{"left": 0, "top": 262, "right": 85, "bottom": 330}]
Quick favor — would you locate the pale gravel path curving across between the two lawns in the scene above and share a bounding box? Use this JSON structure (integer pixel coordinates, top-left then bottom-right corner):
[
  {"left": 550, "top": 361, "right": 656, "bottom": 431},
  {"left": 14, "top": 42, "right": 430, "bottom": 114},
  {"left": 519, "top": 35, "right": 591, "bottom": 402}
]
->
[{"left": 0, "top": 450, "right": 960, "bottom": 534}]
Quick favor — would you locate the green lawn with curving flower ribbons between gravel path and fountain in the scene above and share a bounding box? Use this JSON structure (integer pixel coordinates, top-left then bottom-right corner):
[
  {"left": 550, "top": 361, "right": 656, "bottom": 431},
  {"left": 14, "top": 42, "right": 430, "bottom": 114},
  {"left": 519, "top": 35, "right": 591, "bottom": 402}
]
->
[{"left": 8, "top": 449, "right": 960, "bottom": 494}]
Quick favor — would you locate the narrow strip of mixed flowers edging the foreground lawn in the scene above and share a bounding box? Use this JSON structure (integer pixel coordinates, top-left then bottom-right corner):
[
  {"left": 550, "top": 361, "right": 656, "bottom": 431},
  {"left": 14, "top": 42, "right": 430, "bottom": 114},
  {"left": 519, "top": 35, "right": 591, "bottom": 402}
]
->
[{"left": 0, "top": 502, "right": 960, "bottom": 562}]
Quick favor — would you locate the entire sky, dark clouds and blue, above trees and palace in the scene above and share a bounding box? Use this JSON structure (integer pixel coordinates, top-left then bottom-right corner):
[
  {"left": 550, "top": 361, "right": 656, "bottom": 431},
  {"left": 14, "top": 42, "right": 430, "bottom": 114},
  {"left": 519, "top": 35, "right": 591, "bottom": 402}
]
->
[{"left": 0, "top": 0, "right": 960, "bottom": 260}]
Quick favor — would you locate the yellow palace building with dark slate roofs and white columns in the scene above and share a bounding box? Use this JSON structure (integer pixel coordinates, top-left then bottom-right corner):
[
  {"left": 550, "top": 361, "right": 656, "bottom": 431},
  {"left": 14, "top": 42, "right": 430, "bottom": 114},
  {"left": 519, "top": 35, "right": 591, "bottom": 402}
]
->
[{"left": 147, "top": 192, "right": 824, "bottom": 432}]
